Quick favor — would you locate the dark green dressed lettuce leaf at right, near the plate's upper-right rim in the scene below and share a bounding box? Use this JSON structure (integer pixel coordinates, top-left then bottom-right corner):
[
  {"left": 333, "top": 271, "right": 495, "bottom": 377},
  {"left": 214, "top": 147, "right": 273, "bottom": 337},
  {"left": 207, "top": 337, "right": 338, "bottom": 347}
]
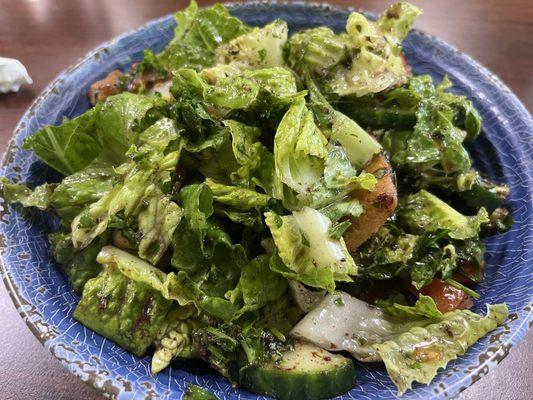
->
[{"left": 374, "top": 75, "right": 481, "bottom": 176}]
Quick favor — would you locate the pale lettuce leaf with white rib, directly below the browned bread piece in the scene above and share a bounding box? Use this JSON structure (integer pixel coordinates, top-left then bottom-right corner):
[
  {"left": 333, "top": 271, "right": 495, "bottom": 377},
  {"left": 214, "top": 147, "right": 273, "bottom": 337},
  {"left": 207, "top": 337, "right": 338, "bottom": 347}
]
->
[{"left": 265, "top": 207, "right": 357, "bottom": 292}]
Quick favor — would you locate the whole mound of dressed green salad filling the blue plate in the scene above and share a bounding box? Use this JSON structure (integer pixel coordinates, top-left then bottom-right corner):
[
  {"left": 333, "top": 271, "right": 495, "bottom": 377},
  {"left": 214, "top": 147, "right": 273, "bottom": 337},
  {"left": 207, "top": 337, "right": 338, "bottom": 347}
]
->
[{"left": 3, "top": 1, "right": 512, "bottom": 400}]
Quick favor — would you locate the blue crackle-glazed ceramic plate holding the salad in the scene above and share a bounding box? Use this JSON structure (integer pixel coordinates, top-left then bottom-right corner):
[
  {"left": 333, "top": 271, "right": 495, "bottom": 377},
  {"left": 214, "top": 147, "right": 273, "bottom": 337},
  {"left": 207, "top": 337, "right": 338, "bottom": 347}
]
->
[{"left": 0, "top": 2, "right": 533, "bottom": 399}]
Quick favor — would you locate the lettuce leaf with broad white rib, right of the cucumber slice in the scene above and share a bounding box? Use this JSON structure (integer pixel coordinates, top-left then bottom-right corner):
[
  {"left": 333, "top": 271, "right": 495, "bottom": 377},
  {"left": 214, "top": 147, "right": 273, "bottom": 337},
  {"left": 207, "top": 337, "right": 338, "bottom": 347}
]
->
[{"left": 291, "top": 292, "right": 508, "bottom": 388}]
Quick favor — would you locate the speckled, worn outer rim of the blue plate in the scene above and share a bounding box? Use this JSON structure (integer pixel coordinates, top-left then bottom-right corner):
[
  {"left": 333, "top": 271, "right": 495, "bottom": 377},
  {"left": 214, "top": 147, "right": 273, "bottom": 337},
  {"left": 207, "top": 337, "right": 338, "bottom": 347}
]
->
[{"left": 0, "top": 0, "right": 533, "bottom": 398}]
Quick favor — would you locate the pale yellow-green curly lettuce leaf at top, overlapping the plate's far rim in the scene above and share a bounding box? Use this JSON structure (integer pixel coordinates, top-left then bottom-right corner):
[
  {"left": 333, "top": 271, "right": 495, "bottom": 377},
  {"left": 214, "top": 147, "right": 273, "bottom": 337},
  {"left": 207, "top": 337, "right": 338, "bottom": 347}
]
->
[{"left": 287, "top": 3, "right": 420, "bottom": 96}]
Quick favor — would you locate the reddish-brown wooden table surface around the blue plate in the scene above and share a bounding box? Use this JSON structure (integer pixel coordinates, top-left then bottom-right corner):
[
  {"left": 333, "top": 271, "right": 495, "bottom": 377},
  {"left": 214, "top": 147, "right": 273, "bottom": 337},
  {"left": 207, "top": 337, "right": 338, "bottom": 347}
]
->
[{"left": 0, "top": 0, "right": 533, "bottom": 400}]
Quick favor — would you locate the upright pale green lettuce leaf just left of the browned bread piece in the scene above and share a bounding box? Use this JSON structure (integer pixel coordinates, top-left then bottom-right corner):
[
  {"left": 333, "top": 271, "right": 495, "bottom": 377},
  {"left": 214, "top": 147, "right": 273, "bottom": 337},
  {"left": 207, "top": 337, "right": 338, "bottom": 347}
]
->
[{"left": 274, "top": 94, "right": 380, "bottom": 210}]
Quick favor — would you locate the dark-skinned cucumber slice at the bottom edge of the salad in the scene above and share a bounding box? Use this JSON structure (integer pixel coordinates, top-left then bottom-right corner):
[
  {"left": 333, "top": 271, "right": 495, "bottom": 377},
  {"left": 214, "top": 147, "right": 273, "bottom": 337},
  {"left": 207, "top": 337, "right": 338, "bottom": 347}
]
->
[{"left": 241, "top": 341, "right": 355, "bottom": 400}]
